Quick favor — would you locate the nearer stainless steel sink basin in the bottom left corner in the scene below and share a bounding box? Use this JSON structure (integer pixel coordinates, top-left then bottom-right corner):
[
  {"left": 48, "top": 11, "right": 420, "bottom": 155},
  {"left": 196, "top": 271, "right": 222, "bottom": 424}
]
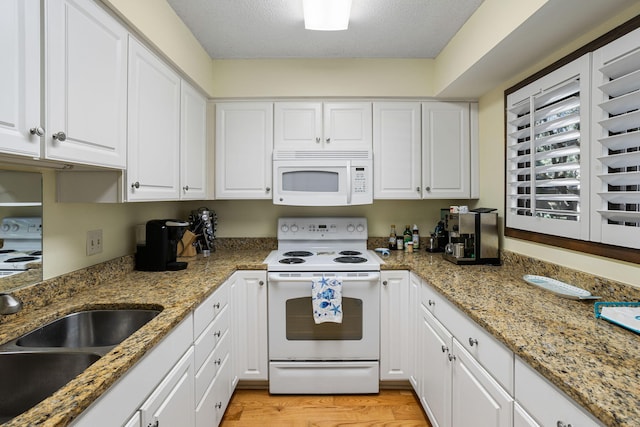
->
[{"left": 0, "top": 352, "right": 100, "bottom": 423}]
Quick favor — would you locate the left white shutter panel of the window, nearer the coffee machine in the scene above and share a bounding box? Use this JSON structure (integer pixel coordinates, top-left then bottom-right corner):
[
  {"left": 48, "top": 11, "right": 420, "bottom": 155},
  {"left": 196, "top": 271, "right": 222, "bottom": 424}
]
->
[{"left": 505, "top": 55, "right": 590, "bottom": 239}]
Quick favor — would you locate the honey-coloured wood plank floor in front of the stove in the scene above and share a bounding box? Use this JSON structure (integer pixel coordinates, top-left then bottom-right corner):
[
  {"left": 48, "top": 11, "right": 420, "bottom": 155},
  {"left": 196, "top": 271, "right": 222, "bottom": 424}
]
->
[{"left": 220, "top": 389, "right": 431, "bottom": 427}]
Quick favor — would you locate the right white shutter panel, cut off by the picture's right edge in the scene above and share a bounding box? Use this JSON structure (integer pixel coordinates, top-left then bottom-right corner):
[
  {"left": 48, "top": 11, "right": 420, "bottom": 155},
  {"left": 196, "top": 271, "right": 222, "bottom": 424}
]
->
[{"left": 591, "top": 30, "right": 640, "bottom": 248}]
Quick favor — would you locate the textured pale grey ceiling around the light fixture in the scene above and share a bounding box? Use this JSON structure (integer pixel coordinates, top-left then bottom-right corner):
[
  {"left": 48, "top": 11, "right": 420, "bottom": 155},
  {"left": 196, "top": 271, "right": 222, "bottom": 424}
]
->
[{"left": 168, "top": 0, "right": 482, "bottom": 59}]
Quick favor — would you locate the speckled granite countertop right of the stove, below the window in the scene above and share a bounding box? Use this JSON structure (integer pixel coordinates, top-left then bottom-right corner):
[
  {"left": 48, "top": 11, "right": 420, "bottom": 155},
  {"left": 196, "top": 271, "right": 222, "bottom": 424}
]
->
[{"left": 383, "top": 251, "right": 640, "bottom": 427}]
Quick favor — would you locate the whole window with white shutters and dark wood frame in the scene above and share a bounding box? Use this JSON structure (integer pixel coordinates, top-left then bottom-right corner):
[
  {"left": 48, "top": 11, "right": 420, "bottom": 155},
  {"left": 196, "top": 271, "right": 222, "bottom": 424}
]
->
[{"left": 505, "top": 15, "right": 640, "bottom": 264}]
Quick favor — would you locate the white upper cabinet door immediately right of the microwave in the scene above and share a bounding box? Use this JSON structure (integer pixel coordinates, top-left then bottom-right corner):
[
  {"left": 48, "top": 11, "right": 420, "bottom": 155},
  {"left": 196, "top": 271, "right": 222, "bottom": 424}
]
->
[{"left": 373, "top": 102, "right": 422, "bottom": 199}]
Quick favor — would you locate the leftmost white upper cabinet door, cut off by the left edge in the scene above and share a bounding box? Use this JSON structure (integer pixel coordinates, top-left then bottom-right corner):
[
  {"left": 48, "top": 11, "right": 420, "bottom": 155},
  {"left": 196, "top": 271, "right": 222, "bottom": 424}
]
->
[{"left": 0, "top": 0, "right": 44, "bottom": 157}]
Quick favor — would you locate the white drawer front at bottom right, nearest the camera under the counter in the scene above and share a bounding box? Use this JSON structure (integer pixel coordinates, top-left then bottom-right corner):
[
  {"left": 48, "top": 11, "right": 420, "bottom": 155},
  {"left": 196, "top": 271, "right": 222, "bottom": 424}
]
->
[{"left": 515, "top": 358, "right": 602, "bottom": 427}]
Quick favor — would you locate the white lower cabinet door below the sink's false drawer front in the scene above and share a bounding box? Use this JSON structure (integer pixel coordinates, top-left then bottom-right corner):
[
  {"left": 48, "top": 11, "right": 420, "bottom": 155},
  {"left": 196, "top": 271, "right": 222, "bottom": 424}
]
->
[{"left": 140, "top": 347, "right": 195, "bottom": 427}]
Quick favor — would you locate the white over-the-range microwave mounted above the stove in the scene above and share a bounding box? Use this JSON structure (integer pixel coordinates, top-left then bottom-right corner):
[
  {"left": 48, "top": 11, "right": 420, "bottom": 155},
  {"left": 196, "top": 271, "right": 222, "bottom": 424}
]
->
[{"left": 273, "top": 151, "right": 373, "bottom": 206}]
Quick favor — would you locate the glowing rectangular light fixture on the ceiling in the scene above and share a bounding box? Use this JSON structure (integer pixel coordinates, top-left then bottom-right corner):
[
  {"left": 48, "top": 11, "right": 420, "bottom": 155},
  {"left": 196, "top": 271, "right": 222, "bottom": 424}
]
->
[{"left": 302, "top": 0, "right": 351, "bottom": 31}]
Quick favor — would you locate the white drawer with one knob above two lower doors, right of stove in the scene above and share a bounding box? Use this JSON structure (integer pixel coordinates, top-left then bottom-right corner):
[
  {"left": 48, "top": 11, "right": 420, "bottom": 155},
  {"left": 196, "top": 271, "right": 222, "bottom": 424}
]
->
[{"left": 438, "top": 303, "right": 514, "bottom": 396}]
